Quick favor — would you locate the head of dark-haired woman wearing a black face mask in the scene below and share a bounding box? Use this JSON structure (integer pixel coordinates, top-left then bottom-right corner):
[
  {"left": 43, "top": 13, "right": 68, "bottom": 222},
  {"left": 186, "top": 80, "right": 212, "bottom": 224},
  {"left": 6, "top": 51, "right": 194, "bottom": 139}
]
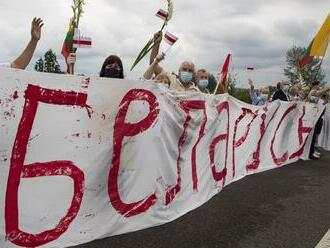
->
[{"left": 100, "top": 55, "right": 124, "bottom": 79}]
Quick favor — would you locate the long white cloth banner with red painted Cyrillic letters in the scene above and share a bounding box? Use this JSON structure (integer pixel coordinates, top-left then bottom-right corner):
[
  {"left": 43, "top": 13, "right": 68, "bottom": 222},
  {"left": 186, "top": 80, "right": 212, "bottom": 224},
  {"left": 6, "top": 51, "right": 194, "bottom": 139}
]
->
[{"left": 0, "top": 69, "right": 320, "bottom": 247}]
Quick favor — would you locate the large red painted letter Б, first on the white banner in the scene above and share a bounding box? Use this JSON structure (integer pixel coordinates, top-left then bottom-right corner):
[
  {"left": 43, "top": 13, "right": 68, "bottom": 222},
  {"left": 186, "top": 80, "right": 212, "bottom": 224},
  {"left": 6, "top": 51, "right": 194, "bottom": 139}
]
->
[{"left": 5, "top": 84, "right": 87, "bottom": 247}]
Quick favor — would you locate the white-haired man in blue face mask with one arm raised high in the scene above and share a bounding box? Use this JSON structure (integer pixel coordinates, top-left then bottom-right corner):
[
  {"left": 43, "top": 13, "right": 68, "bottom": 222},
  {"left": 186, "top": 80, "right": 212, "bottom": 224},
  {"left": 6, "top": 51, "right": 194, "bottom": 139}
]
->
[{"left": 145, "top": 32, "right": 200, "bottom": 92}]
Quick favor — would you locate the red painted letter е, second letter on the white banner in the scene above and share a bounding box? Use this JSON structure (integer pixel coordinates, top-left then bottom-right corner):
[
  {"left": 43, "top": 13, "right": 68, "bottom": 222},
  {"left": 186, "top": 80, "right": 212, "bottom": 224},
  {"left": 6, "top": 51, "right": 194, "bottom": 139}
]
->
[{"left": 108, "top": 89, "right": 159, "bottom": 217}]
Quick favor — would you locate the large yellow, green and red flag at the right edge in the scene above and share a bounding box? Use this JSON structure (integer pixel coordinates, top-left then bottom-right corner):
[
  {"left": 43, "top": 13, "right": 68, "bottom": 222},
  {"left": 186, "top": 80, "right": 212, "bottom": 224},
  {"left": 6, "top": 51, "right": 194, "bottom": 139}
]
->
[{"left": 299, "top": 13, "right": 330, "bottom": 68}]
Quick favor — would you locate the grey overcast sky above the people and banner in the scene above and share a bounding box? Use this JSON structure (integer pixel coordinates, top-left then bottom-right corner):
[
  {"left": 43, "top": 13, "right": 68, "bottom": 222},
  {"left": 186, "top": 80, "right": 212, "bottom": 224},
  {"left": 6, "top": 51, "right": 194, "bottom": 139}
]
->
[{"left": 0, "top": 0, "right": 330, "bottom": 86}]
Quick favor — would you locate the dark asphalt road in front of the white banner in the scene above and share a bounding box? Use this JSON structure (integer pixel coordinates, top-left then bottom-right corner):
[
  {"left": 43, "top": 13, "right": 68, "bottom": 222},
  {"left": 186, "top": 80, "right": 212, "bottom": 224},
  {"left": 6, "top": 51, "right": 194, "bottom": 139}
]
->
[{"left": 77, "top": 153, "right": 330, "bottom": 248}]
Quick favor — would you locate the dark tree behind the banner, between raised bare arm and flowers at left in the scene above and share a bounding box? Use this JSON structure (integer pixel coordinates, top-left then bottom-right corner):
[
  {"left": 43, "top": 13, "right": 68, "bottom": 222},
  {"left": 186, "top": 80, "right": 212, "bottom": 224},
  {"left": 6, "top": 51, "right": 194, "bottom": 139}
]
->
[{"left": 34, "top": 49, "right": 63, "bottom": 73}]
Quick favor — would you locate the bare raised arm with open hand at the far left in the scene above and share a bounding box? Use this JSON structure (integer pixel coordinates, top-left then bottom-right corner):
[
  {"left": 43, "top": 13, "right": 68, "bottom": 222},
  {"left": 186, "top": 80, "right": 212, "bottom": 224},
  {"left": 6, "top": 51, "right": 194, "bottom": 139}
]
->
[{"left": 0, "top": 17, "right": 44, "bottom": 69}]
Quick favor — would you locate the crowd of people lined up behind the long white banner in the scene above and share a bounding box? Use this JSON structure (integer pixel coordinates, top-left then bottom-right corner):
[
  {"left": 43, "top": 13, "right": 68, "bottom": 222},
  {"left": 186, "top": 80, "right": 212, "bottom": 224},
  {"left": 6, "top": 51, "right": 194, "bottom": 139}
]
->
[{"left": 0, "top": 18, "right": 330, "bottom": 159}]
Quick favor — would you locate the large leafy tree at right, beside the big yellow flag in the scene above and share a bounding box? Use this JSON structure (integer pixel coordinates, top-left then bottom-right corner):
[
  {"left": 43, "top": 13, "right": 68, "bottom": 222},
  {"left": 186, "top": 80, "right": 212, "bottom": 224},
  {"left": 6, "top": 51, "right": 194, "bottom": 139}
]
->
[{"left": 284, "top": 46, "right": 325, "bottom": 83}]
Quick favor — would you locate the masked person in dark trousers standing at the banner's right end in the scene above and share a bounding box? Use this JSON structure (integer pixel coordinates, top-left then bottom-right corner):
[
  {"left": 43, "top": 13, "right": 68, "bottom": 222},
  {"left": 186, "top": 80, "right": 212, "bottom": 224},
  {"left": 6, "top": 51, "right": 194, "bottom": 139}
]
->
[{"left": 308, "top": 81, "right": 330, "bottom": 159}]
